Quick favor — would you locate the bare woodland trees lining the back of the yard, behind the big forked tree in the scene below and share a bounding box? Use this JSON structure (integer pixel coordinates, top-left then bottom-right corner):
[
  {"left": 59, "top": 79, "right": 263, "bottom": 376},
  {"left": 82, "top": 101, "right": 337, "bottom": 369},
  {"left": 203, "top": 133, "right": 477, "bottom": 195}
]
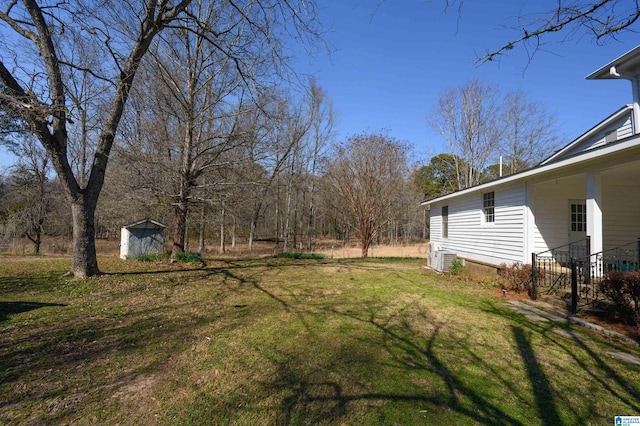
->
[{"left": 0, "top": 75, "right": 557, "bottom": 256}]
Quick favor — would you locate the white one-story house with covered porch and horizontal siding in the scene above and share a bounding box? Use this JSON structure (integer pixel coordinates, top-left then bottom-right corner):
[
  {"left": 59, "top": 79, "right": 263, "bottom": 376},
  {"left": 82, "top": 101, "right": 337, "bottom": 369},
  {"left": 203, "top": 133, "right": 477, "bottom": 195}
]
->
[{"left": 422, "top": 46, "right": 640, "bottom": 272}]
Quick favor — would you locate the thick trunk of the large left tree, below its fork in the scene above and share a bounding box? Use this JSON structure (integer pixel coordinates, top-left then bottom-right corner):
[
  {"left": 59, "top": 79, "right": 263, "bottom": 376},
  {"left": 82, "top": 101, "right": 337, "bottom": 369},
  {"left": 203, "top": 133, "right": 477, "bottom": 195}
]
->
[{"left": 70, "top": 197, "right": 100, "bottom": 278}]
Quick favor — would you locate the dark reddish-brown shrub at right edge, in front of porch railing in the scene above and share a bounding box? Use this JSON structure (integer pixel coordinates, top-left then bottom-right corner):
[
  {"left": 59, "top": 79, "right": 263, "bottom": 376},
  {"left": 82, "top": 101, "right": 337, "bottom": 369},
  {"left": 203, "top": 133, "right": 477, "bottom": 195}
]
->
[{"left": 599, "top": 271, "right": 640, "bottom": 327}]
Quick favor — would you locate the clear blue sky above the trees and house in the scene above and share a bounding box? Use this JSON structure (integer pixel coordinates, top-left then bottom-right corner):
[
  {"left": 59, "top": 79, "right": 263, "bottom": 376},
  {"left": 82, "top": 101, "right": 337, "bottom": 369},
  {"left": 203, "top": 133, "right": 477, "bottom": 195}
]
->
[{"left": 0, "top": 0, "right": 638, "bottom": 169}]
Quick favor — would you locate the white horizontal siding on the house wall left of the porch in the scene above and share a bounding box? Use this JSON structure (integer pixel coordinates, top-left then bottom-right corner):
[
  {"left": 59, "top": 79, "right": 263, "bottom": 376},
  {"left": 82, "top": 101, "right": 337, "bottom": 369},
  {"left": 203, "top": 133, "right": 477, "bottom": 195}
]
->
[{"left": 432, "top": 184, "right": 530, "bottom": 265}]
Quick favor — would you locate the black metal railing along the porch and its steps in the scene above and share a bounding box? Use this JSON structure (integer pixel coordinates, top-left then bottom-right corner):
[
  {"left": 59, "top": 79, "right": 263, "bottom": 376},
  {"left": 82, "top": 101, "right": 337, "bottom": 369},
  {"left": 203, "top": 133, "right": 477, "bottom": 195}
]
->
[{"left": 531, "top": 237, "right": 640, "bottom": 313}]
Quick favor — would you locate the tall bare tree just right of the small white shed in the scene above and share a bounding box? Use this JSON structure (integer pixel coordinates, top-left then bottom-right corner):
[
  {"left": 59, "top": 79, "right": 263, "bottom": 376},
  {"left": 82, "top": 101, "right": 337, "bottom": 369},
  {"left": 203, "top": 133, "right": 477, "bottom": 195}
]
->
[{"left": 144, "top": 0, "right": 246, "bottom": 256}]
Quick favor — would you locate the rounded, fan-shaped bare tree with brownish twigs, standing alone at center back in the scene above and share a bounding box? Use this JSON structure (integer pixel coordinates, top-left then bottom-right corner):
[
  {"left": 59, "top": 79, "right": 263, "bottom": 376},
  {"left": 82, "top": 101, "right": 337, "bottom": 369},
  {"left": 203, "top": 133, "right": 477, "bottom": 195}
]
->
[{"left": 325, "top": 134, "right": 409, "bottom": 257}]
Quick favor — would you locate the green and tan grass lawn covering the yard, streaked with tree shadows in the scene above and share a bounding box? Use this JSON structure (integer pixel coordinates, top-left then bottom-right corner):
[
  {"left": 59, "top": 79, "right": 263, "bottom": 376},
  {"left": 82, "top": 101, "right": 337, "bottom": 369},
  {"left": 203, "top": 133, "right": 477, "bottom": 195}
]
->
[{"left": 0, "top": 257, "right": 640, "bottom": 425}]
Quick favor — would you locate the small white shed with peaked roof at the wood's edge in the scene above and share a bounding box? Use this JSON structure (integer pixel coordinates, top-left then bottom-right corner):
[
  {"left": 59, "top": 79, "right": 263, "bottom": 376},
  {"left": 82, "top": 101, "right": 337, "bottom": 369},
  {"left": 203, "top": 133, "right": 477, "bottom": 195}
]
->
[{"left": 120, "top": 219, "right": 167, "bottom": 259}]
